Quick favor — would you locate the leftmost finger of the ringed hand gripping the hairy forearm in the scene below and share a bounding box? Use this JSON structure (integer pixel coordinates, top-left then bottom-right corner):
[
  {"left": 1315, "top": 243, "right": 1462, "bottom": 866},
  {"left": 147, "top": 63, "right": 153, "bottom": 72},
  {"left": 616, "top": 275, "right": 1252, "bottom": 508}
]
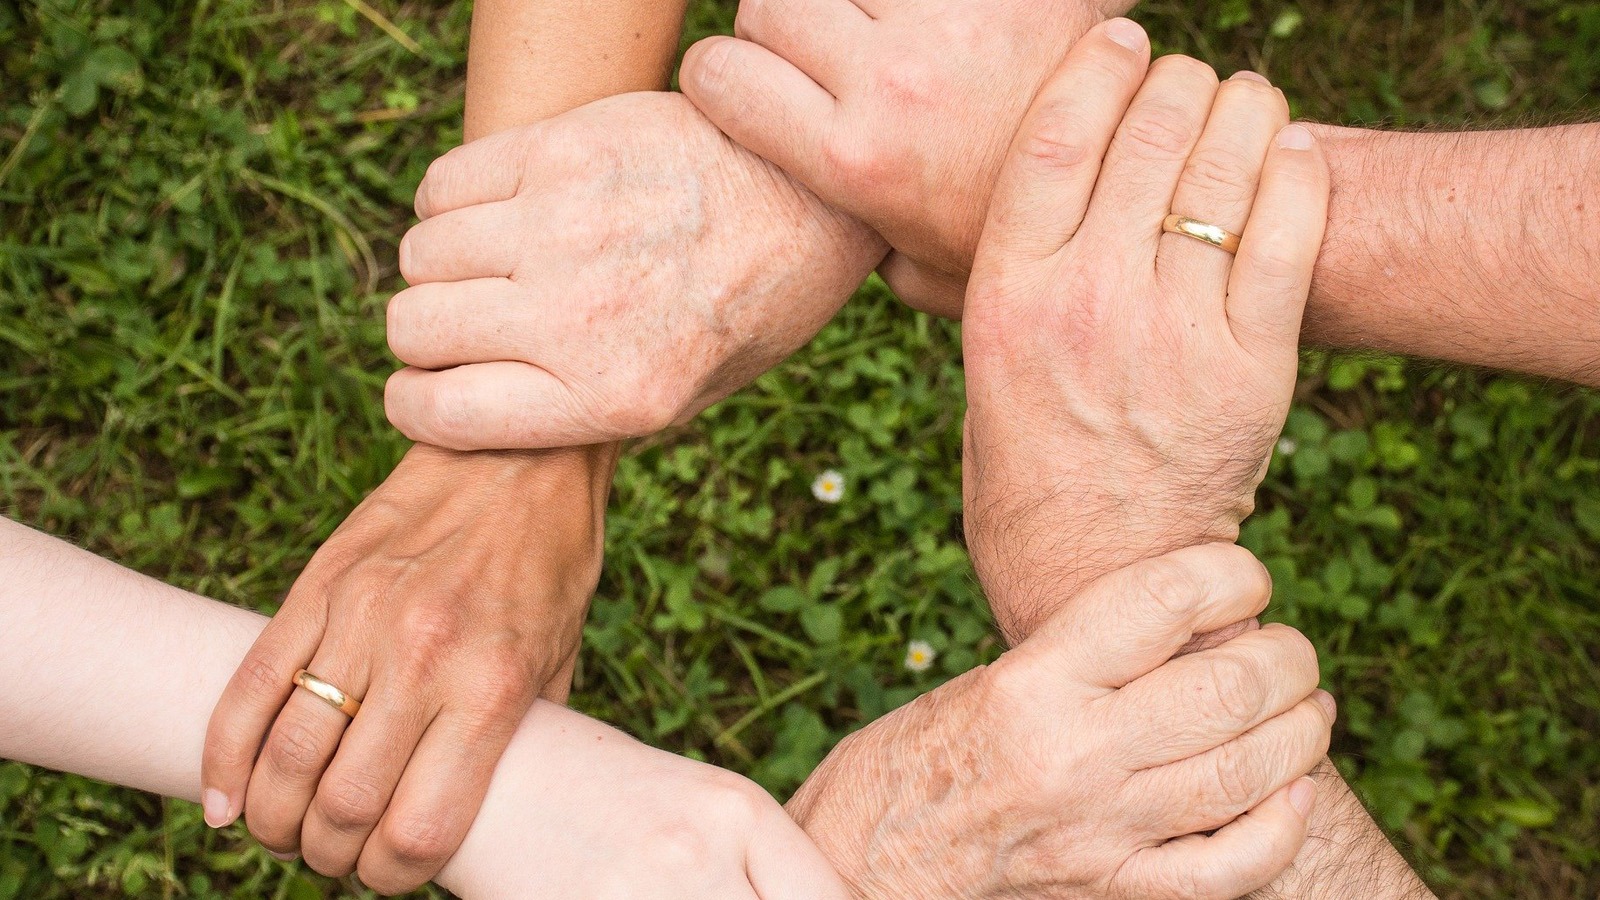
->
[{"left": 984, "top": 19, "right": 1154, "bottom": 259}]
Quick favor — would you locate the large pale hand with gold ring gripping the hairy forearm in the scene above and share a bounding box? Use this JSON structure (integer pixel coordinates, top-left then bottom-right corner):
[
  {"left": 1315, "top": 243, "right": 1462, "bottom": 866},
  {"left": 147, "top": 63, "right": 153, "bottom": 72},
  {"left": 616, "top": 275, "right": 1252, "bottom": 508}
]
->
[{"left": 963, "top": 19, "right": 1328, "bottom": 636}]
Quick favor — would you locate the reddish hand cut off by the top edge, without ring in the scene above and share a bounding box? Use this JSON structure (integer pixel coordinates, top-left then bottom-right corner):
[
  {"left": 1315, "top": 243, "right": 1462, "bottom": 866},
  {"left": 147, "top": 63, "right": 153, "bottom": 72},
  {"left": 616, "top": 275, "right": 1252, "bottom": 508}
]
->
[{"left": 678, "top": 0, "right": 1133, "bottom": 315}]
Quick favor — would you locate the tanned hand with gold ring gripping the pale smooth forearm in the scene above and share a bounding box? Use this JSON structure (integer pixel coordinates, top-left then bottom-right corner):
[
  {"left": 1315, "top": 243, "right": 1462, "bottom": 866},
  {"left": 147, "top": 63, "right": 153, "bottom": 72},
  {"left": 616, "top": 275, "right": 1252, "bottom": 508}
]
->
[{"left": 202, "top": 447, "right": 613, "bottom": 892}]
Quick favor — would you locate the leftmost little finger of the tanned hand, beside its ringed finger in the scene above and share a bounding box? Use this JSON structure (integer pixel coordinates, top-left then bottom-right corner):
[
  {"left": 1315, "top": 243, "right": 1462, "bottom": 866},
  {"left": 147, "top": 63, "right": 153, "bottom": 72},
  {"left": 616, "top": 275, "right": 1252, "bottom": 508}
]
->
[{"left": 200, "top": 591, "right": 326, "bottom": 828}]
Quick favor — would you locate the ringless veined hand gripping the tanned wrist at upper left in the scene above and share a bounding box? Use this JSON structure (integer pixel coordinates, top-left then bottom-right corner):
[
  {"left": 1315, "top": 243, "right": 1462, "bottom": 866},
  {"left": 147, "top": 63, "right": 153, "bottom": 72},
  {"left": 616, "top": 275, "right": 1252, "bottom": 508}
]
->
[{"left": 387, "top": 93, "right": 885, "bottom": 450}]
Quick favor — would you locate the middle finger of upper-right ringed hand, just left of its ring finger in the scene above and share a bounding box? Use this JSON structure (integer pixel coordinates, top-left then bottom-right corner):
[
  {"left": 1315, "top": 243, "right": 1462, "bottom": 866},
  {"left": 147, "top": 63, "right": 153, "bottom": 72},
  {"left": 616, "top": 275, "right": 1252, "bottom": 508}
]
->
[{"left": 1083, "top": 56, "right": 1216, "bottom": 259}]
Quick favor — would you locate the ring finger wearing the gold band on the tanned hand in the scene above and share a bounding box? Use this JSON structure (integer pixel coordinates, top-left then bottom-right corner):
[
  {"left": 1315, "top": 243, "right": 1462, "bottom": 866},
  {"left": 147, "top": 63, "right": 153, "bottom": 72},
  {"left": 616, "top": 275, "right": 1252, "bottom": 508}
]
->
[{"left": 245, "top": 644, "right": 368, "bottom": 855}]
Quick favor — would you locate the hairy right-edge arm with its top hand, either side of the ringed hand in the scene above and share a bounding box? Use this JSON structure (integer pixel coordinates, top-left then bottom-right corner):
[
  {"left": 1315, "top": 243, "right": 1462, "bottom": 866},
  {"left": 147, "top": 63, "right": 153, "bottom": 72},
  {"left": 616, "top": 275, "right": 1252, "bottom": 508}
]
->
[{"left": 680, "top": 0, "right": 1600, "bottom": 386}]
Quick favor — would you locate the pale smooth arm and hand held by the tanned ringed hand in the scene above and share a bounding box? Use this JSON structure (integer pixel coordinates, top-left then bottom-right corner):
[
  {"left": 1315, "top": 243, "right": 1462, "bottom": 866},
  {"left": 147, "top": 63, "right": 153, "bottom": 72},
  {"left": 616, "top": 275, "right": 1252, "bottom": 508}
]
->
[{"left": 0, "top": 519, "right": 848, "bottom": 900}]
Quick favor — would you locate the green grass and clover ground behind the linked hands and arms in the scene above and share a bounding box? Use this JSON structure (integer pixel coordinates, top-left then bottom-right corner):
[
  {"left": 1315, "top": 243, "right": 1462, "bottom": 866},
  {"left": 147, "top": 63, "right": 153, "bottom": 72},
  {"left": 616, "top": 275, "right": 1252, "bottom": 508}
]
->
[{"left": 0, "top": 0, "right": 1600, "bottom": 900}]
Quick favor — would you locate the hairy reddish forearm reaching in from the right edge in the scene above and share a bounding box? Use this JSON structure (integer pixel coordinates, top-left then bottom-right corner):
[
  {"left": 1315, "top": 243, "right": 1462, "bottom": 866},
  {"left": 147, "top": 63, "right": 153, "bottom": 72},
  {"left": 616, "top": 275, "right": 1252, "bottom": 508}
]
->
[{"left": 1306, "top": 125, "right": 1600, "bottom": 386}]
